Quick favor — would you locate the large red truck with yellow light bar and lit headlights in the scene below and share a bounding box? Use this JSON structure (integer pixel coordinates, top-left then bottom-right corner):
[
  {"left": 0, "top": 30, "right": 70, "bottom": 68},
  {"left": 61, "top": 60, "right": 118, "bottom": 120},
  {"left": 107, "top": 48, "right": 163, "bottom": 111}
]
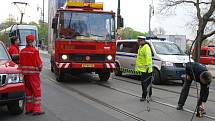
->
[{"left": 49, "top": 0, "right": 119, "bottom": 81}]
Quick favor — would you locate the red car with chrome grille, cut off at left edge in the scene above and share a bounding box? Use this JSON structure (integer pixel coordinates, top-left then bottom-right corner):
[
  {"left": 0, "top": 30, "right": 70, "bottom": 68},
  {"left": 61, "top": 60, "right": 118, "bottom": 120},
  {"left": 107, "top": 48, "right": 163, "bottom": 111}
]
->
[{"left": 0, "top": 41, "right": 25, "bottom": 114}]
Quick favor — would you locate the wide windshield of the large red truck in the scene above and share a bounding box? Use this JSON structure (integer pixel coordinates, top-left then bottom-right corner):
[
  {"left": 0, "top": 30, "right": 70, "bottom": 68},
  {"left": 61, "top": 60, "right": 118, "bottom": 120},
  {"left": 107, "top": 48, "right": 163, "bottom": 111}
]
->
[{"left": 59, "top": 11, "right": 115, "bottom": 41}]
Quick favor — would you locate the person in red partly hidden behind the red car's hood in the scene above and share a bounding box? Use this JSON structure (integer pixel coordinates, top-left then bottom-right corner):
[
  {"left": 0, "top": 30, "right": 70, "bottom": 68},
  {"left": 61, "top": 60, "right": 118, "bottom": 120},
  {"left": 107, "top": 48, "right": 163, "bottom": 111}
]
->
[{"left": 8, "top": 36, "right": 19, "bottom": 60}]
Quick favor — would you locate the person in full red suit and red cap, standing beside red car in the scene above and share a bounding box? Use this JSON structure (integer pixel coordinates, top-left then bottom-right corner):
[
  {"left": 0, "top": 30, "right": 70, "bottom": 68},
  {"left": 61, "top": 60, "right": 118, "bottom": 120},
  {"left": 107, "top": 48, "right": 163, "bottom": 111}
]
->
[{"left": 20, "top": 34, "right": 44, "bottom": 115}]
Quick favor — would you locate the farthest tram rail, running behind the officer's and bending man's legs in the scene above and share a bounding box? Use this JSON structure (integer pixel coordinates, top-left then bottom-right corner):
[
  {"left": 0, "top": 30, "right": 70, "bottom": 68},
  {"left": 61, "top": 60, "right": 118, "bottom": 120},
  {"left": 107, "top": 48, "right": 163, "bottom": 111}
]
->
[{"left": 113, "top": 77, "right": 215, "bottom": 103}]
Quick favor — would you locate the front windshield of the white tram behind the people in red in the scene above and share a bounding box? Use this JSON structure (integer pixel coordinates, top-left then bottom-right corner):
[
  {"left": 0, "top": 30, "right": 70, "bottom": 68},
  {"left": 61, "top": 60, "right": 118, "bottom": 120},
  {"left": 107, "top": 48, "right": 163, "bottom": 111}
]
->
[{"left": 19, "top": 29, "right": 37, "bottom": 46}]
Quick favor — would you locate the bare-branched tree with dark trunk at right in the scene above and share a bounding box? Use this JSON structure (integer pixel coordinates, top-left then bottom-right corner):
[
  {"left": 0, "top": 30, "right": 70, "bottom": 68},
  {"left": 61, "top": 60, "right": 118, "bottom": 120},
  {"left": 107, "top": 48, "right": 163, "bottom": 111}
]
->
[{"left": 160, "top": 0, "right": 215, "bottom": 61}]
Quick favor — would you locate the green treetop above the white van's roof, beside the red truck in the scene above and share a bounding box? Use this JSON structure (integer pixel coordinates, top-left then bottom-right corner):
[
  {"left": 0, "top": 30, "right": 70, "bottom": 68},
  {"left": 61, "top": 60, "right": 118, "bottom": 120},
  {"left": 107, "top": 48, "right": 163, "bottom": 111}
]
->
[{"left": 119, "top": 27, "right": 147, "bottom": 39}]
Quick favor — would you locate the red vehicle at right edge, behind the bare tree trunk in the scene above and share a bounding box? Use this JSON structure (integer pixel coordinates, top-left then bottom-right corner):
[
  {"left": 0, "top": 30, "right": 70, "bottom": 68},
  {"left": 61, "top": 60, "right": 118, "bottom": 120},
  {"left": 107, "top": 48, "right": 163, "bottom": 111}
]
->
[{"left": 199, "top": 46, "right": 215, "bottom": 64}]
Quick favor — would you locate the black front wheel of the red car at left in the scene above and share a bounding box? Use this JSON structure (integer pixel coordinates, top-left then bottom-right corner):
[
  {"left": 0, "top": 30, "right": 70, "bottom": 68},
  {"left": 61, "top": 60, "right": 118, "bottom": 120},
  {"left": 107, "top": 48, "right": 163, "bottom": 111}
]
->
[{"left": 7, "top": 100, "right": 25, "bottom": 114}]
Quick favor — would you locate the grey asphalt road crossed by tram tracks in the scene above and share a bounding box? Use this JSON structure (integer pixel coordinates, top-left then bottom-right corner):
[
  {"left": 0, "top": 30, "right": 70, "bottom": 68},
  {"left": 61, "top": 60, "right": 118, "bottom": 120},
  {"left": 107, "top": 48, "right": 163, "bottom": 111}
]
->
[{"left": 0, "top": 51, "right": 215, "bottom": 121}]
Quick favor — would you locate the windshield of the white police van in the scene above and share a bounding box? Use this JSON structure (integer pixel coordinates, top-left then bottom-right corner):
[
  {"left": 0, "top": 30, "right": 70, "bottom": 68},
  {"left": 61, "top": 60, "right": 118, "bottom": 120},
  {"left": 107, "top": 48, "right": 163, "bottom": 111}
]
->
[{"left": 153, "top": 42, "right": 185, "bottom": 55}]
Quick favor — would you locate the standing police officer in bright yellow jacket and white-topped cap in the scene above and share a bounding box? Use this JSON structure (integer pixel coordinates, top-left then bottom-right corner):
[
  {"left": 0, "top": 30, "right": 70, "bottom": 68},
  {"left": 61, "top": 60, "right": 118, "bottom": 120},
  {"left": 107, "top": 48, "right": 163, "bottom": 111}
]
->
[{"left": 135, "top": 37, "right": 152, "bottom": 101}]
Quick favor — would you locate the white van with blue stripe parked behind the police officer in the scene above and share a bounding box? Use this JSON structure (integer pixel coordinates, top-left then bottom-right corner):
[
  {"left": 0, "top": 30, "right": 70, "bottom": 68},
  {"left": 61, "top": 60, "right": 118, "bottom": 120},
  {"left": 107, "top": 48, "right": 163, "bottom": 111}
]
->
[{"left": 115, "top": 38, "right": 189, "bottom": 84}]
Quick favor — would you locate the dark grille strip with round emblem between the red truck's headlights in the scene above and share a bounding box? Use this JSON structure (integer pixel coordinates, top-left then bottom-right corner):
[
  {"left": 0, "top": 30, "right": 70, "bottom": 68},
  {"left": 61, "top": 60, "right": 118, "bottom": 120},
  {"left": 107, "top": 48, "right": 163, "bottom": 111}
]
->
[{"left": 69, "top": 54, "right": 107, "bottom": 62}]
